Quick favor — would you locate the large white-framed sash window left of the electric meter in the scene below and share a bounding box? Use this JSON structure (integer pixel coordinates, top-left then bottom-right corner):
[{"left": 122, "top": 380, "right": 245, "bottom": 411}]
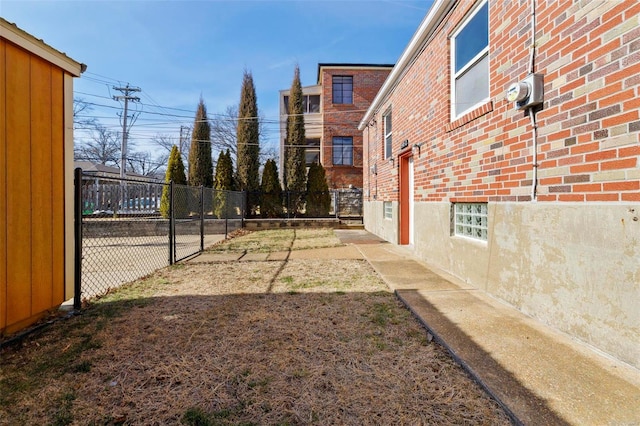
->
[{"left": 451, "top": 0, "right": 489, "bottom": 119}]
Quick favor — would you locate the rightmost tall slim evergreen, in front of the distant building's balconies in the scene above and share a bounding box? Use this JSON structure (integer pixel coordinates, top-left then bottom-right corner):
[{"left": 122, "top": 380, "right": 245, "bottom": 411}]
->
[{"left": 284, "top": 65, "right": 307, "bottom": 215}]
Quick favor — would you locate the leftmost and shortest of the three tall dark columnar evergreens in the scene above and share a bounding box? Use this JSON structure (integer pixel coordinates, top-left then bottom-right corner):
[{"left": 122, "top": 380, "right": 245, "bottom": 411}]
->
[{"left": 189, "top": 98, "right": 213, "bottom": 188}]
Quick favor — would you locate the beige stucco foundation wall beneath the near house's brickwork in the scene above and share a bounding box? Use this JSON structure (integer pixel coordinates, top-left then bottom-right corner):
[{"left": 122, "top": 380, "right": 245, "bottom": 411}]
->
[{"left": 364, "top": 201, "right": 640, "bottom": 368}]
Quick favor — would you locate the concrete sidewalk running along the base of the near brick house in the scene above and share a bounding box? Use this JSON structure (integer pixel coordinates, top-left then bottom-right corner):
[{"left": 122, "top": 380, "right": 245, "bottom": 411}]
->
[{"left": 336, "top": 230, "right": 640, "bottom": 425}]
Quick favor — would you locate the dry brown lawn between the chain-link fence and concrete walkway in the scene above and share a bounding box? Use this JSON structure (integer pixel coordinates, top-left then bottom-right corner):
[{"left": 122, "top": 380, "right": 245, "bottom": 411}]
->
[{"left": 0, "top": 231, "right": 509, "bottom": 425}]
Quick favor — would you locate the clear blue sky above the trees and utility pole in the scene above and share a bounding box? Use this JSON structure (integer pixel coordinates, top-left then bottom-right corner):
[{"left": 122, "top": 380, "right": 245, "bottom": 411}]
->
[{"left": 0, "top": 0, "right": 431, "bottom": 160}]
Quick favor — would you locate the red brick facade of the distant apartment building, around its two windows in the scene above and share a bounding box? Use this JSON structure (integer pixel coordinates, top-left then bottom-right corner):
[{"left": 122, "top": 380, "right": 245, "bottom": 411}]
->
[{"left": 320, "top": 68, "right": 391, "bottom": 188}]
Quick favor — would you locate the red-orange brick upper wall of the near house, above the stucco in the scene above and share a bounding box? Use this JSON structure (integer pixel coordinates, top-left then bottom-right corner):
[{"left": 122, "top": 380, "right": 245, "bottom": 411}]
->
[{"left": 364, "top": 0, "right": 640, "bottom": 202}]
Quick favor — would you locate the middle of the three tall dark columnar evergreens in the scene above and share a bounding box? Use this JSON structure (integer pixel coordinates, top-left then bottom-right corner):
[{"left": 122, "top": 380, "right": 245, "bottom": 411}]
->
[{"left": 236, "top": 70, "right": 260, "bottom": 214}]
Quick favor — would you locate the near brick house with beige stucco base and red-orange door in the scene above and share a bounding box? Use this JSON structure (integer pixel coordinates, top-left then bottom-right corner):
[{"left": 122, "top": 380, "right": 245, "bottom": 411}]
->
[{"left": 359, "top": 0, "right": 640, "bottom": 368}]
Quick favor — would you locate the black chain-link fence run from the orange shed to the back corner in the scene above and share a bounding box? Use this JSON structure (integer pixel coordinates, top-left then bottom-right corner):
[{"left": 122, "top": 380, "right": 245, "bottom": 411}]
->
[{"left": 74, "top": 169, "right": 244, "bottom": 302}]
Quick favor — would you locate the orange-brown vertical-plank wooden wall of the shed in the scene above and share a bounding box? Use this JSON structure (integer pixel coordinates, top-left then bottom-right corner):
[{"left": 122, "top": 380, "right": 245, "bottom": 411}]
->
[{"left": 0, "top": 39, "right": 65, "bottom": 333}]
